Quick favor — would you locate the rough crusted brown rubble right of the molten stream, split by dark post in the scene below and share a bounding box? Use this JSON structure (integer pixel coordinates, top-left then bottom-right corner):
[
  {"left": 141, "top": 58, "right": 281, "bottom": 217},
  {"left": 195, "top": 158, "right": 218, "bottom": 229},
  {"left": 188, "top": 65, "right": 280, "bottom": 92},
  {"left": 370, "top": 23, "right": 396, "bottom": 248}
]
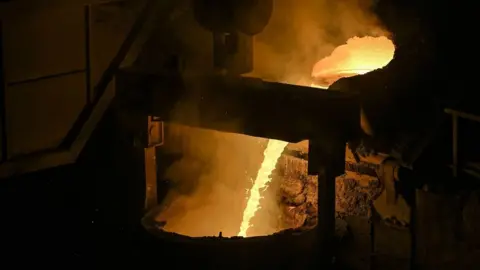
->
[{"left": 274, "top": 144, "right": 381, "bottom": 229}]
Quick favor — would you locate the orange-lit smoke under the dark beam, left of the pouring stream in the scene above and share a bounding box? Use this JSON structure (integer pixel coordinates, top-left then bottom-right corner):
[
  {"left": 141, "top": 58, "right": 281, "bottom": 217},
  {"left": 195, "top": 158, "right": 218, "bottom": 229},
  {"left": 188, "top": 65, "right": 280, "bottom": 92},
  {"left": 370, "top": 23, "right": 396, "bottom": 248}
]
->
[{"left": 157, "top": 124, "right": 266, "bottom": 236}]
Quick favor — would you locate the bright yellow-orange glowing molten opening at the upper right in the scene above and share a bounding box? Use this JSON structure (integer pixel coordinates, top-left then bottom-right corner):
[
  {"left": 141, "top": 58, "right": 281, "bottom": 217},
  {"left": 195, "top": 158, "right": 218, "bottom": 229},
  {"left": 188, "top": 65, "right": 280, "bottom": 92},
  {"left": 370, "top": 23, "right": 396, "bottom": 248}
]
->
[{"left": 312, "top": 37, "right": 395, "bottom": 88}]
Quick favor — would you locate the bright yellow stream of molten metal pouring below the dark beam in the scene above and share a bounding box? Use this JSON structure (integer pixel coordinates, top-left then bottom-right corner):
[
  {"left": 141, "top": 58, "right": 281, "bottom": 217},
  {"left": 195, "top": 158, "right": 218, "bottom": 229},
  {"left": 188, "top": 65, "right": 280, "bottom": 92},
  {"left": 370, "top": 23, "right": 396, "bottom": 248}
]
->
[{"left": 238, "top": 140, "right": 288, "bottom": 237}]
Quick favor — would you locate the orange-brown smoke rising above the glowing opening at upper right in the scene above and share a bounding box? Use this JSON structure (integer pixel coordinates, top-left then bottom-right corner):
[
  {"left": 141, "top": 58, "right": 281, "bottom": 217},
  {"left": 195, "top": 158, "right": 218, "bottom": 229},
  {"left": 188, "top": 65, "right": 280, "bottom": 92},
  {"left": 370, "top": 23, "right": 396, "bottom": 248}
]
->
[{"left": 253, "top": 0, "right": 388, "bottom": 84}]
